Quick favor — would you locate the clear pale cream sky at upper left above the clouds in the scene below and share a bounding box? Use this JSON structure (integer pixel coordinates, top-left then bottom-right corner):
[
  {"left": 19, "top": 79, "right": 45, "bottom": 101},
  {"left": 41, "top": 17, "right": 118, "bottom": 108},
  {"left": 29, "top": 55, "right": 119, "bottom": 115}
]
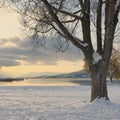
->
[{"left": 0, "top": 8, "right": 22, "bottom": 39}]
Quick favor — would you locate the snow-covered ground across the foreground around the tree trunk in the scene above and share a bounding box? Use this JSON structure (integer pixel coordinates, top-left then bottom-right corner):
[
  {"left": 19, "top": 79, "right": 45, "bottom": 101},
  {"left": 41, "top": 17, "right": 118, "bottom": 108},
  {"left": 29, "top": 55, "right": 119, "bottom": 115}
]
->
[{"left": 0, "top": 85, "right": 120, "bottom": 120}]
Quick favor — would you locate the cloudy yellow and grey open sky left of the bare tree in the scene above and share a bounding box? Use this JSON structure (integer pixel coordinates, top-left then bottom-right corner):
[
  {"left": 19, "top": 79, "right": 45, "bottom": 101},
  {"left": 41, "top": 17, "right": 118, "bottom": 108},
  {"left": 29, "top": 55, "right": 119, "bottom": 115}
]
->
[{"left": 0, "top": 8, "right": 83, "bottom": 77}]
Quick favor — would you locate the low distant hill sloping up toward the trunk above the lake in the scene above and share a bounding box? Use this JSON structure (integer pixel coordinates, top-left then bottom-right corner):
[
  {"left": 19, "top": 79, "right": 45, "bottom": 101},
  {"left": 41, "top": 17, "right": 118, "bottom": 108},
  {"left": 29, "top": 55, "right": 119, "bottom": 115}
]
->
[{"left": 37, "top": 70, "right": 90, "bottom": 78}]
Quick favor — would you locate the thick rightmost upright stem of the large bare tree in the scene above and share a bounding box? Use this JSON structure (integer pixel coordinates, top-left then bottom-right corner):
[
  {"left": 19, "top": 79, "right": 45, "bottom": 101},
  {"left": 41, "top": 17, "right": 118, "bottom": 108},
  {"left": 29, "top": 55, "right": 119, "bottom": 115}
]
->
[{"left": 103, "top": 0, "right": 118, "bottom": 66}]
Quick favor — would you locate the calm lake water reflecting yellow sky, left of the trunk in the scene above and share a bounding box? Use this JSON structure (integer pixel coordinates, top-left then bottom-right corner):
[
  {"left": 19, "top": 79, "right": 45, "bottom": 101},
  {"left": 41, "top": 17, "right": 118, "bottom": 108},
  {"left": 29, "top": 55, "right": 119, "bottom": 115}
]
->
[{"left": 0, "top": 78, "right": 90, "bottom": 86}]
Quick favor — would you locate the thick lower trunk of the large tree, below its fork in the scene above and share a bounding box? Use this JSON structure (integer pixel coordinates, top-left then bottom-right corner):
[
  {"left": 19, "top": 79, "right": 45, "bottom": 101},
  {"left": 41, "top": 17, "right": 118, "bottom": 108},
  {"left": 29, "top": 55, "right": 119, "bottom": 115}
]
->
[{"left": 91, "top": 64, "right": 108, "bottom": 101}]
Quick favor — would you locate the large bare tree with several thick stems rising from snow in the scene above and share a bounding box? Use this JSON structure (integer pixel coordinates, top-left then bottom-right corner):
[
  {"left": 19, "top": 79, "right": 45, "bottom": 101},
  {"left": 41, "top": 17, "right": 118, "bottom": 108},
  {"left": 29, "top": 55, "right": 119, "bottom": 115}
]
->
[{"left": 7, "top": 0, "right": 120, "bottom": 101}]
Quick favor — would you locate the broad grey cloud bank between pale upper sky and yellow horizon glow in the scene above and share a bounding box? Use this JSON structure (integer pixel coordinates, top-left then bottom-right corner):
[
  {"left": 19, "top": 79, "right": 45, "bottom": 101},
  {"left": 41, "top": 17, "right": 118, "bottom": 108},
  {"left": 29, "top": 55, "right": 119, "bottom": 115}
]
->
[{"left": 0, "top": 37, "right": 81, "bottom": 66}]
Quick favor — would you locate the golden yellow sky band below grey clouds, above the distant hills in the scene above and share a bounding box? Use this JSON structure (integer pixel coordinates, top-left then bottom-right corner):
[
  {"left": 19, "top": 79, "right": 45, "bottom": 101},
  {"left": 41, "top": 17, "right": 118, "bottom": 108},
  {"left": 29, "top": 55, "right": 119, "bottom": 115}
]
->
[{"left": 1, "top": 60, "right": 83, "bottom": 76}]
